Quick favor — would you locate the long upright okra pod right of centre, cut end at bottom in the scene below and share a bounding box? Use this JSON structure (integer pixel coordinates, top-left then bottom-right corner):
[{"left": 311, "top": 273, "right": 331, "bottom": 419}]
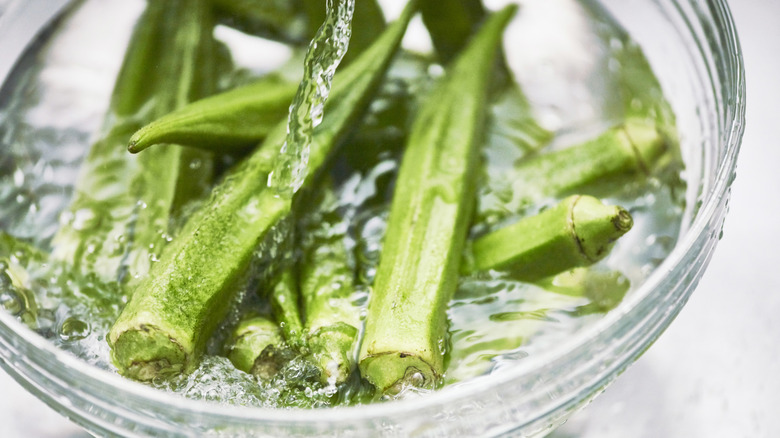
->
[{"left": 359, "top": 6, "right": 516, "bottom": 393}]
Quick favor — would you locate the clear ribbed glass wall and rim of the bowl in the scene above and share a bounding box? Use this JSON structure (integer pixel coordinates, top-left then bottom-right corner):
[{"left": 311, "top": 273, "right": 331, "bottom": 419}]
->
[{"left": 0, "top": 0, "right": 745, "bottom": 437}]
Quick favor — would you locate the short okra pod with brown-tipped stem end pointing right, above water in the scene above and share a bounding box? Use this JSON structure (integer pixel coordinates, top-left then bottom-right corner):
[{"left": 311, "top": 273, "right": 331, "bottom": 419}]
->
[{"left": 467, "top": 195, "right": 633, "bottom": 281}]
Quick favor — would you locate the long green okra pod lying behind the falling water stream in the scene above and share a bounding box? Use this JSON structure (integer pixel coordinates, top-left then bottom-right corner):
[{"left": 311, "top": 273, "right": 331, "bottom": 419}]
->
[{"left": 108, "top": 1, "right": 415, "bottom": 380}]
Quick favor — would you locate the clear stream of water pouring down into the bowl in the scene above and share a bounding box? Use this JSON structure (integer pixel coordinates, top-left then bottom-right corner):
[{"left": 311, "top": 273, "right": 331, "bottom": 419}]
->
[{"left": 268, "top": 0, "right": 355, "bottom": 198}]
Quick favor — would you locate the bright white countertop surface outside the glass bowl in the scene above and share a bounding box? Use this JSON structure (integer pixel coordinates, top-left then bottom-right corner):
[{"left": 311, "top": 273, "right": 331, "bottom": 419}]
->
[{"left": 0, "top": 0, "right": 780, "bottom": 438}]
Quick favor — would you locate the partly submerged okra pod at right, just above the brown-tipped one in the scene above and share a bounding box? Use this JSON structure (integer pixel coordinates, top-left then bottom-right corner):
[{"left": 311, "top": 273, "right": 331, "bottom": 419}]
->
[{"left": 480, "top": 119, "right": 669, "bottom": 224}]
